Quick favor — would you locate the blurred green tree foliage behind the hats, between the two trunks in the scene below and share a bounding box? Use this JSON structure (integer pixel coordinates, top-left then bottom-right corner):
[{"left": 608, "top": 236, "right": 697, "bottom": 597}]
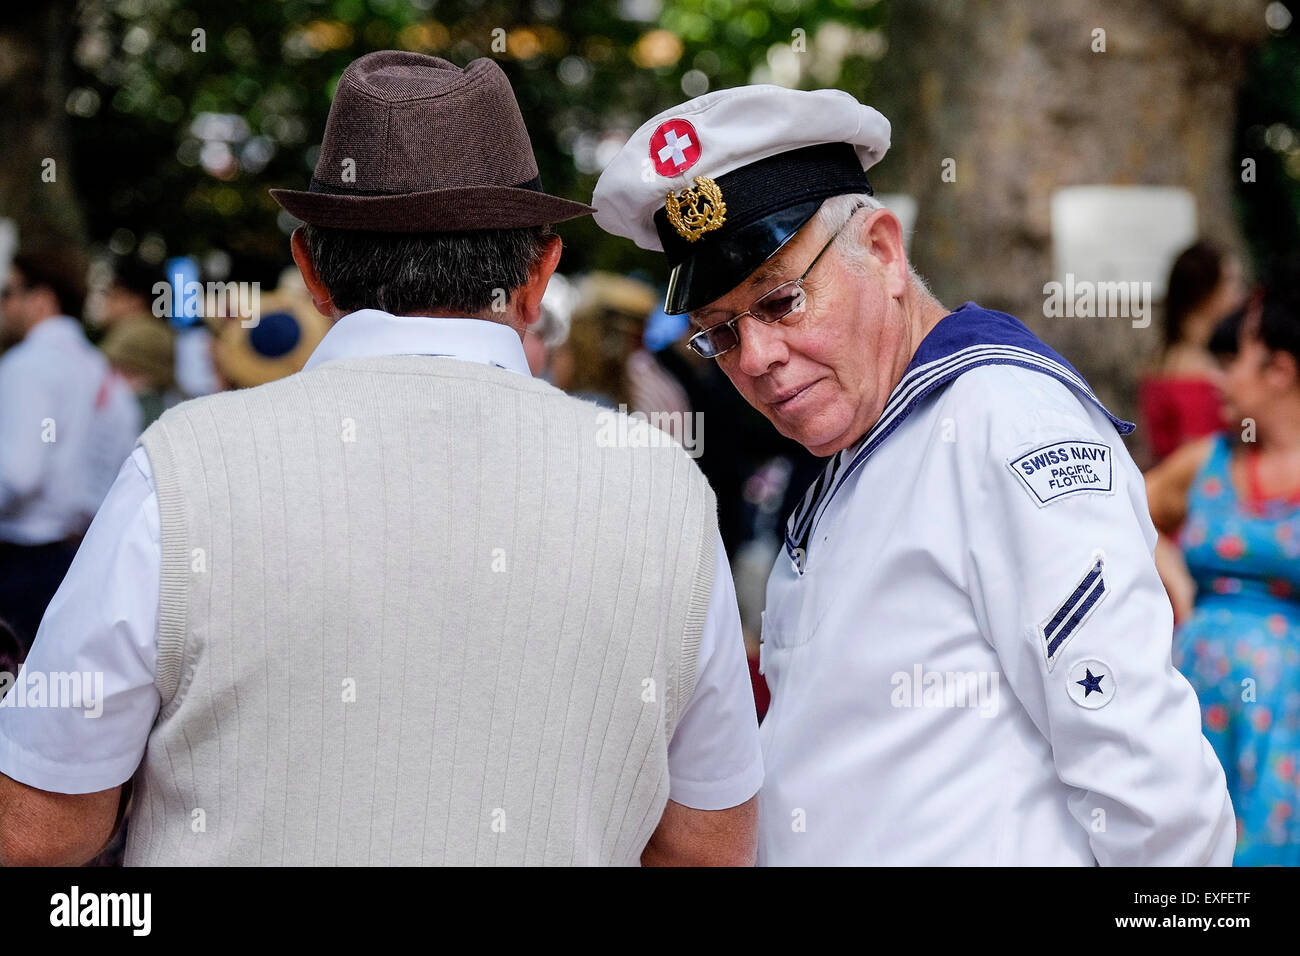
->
[{"left": 68, "top": 0, "right": 885, "bottom": 281}]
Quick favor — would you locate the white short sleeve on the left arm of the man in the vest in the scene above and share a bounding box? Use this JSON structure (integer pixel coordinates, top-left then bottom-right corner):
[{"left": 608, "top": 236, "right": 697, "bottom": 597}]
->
[{"left": 0, "top": 447, "right": 163, "bottom": 793}]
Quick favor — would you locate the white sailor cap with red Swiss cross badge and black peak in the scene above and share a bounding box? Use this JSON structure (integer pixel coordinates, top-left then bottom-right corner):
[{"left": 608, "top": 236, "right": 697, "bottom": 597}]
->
[{"left": 592, "top": 86, "right": 889, "bottom": 315}]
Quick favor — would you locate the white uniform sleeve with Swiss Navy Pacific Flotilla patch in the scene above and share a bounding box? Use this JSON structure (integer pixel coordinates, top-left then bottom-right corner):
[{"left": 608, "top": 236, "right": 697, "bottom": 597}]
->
[{"left": 954, "top": 371, "right": 1236, "bottom": 866}]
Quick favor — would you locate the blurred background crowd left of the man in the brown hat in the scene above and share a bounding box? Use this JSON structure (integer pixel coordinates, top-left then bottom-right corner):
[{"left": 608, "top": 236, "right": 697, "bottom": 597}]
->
[{"left": 0, "top": 245, "right": 328, "bottom": 659}]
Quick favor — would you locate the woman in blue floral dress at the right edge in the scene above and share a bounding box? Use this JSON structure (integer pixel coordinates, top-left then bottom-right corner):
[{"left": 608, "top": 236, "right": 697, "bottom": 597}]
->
[{"left": 1148, "top": 278, "right": 1300, "bottom": 866}]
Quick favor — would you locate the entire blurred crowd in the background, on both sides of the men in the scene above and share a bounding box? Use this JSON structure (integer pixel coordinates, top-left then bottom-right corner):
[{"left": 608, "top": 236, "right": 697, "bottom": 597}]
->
[{"left": 0, "top": 241, "right": 1300, "bottom": 865}]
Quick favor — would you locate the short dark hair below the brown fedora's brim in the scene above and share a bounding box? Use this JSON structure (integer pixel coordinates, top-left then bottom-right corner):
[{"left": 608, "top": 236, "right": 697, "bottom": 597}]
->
[{"left": 303, "top": 225, "right": 553, "bottom": 315}]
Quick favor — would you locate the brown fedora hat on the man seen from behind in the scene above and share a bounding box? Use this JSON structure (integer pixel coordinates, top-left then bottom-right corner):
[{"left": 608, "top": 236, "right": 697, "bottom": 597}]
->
[{"left": 270, "top": 49, "right": 594, "bottom": 233}]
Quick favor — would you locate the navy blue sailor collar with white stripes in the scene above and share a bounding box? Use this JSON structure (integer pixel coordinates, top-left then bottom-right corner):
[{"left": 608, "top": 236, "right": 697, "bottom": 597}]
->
[{"left": 785, "top": 302, "right": 1134, "bottom": 575}]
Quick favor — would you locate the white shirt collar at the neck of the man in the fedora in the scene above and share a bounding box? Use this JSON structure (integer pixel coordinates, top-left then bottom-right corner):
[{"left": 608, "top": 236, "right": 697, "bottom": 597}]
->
[{"left": 303, "top": 308, "right": 532, "bottom": 377}]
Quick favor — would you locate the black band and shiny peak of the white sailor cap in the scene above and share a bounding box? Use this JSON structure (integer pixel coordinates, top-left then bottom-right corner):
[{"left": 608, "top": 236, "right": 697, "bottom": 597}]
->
[{"left": 654, "top": 143, "right": 872, "bottom": 315}]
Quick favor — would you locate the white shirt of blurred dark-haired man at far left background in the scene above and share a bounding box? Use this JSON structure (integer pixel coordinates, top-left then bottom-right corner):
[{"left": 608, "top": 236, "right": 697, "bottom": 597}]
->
[{"left": 0, "top": 315, "right": 140, "bottom": 545}]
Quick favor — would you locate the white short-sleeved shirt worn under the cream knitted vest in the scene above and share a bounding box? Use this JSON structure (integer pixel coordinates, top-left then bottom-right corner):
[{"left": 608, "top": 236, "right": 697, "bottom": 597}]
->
[{"left": 0, "top": 310, "right": 763, "bottom": 810}]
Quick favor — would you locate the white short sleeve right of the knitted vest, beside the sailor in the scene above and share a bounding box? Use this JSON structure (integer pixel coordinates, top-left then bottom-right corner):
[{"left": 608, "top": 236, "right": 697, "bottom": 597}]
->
[{"left": 668, "top": 537, "right": 763, "bottom": 810}]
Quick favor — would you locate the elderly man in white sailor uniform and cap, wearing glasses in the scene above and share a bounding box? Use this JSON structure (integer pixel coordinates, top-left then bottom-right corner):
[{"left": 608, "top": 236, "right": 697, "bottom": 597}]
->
[{"left": 593, "top": 86, "right": 1236, "bottom": 865}]
